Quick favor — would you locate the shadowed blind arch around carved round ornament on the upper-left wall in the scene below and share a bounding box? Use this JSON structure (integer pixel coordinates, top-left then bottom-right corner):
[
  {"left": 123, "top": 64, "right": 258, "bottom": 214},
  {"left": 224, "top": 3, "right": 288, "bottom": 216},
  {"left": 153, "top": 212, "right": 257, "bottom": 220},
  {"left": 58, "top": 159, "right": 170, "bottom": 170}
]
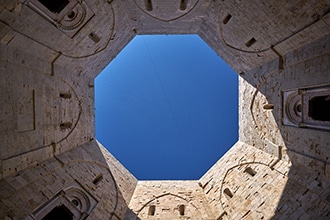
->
[{"left": 6, "top": 0, "right": 115, "bottom": 58}]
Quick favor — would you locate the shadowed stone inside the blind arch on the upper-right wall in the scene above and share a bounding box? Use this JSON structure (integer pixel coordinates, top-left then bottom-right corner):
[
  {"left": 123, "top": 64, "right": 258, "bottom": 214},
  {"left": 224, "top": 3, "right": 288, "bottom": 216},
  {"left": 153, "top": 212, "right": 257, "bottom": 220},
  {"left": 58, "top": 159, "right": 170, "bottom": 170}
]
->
[{"left": 218, "top": 0, "right": 326, "bottom": 53}]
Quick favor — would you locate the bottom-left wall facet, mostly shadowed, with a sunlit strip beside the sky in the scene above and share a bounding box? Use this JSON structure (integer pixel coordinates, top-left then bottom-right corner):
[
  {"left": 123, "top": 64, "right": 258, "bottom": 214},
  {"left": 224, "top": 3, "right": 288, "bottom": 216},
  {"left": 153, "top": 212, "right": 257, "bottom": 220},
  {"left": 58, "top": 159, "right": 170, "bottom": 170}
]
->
[{"left": 0, "top": 141, "right": 137, "bottom": 219}]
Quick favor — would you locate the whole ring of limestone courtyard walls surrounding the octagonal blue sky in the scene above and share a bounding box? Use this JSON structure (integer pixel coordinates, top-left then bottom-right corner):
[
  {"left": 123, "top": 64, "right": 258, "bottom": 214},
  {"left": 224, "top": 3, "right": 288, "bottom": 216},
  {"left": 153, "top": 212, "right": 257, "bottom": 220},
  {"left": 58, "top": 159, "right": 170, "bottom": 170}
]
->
[{"left": 0, "top": 0, "right": 330, "bottom": 220}]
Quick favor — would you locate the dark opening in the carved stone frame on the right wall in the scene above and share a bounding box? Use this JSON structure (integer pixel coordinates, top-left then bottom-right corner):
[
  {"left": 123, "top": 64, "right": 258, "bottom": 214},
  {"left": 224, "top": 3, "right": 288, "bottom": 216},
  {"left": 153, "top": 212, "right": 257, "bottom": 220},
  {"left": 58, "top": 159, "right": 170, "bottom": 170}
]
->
[{"left": 308, "top": 95, "right": 330, "bottom": 121}]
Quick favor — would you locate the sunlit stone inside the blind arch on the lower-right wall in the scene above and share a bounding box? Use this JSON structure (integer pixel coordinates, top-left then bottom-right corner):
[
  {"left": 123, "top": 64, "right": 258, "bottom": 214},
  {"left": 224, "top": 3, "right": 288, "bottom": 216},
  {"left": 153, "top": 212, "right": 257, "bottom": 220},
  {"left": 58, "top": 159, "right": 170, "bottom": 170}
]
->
[{"left": 220, "top": 162, "right": 288, "bottom": 219}]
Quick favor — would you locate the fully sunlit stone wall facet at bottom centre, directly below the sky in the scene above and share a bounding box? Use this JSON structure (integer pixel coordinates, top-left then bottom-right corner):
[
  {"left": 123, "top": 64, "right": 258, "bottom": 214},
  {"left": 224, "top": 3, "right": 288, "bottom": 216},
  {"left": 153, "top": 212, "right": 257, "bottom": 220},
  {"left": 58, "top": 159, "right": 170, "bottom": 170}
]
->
[{"left": 129, "top": 181, "right": 215, "bottom": 219}]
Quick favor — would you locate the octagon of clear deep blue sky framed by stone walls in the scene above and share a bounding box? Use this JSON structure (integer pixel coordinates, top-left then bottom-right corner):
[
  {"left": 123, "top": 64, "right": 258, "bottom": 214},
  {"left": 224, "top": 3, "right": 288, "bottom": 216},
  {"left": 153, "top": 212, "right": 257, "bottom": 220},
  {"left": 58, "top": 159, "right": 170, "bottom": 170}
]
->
[{"left": 95, "top": 35, "right": 238, "bottom": 180}]
